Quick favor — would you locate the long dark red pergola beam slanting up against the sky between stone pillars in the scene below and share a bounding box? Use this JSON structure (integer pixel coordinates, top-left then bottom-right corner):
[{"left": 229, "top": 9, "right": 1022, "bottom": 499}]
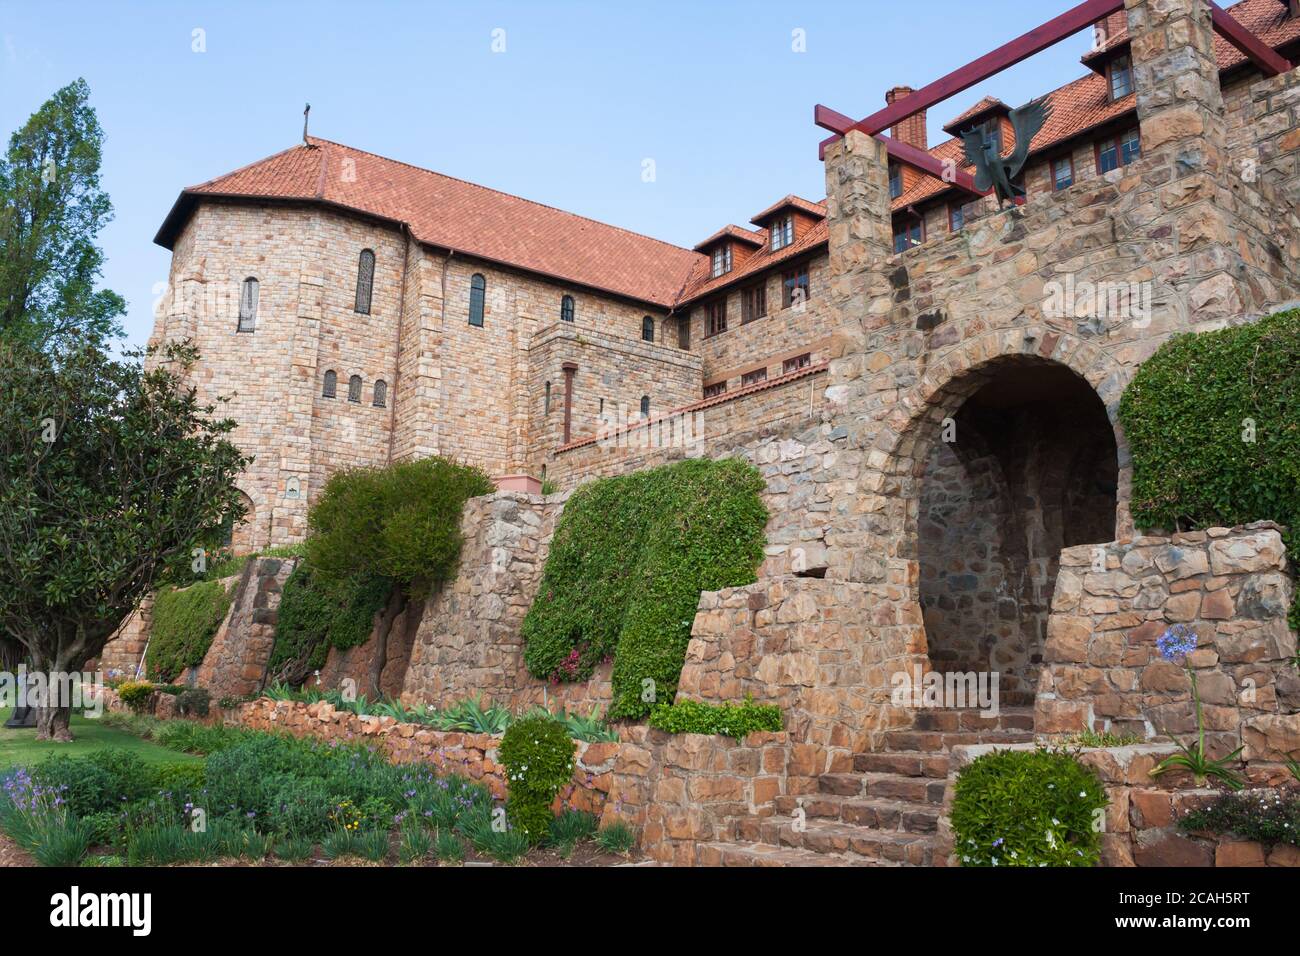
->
[{"left": 814, "top": 0, "right": 1125, "bottom": 142}]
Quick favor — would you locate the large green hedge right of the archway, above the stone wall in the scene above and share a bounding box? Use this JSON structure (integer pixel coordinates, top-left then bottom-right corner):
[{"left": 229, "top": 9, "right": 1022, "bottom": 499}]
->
[{"left": 1119, "top": 311, "right": 1300, "bottom": 627}]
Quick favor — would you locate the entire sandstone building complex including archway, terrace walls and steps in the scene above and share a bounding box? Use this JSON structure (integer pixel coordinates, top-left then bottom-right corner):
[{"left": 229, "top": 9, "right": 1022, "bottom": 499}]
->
[{"left": 116, "top": 0, "right": 1300, "bottom": 864}]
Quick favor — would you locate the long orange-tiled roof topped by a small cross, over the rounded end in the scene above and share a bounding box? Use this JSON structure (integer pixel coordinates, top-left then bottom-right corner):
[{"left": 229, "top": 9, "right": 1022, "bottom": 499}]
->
[{"left": 153, "top": 137, "right": 703, "bottom": 307}]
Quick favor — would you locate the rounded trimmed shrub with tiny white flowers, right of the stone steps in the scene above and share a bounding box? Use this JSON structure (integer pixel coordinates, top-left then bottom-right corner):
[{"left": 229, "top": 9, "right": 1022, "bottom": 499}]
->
[{"left": 953, "top": 749, "right": 1109, "bottom": 866}]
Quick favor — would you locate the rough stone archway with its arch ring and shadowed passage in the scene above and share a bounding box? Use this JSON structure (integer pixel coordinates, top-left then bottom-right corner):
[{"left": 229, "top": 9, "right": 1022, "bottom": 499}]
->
[{"left": 859, "top": 328, "right": 1132, "bottom": 704}]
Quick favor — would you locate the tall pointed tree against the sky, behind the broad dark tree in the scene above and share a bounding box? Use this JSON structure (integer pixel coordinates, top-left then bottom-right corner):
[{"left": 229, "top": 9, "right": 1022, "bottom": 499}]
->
[{"left": 0, "top": 79, "right": 126, "bottom": 350}]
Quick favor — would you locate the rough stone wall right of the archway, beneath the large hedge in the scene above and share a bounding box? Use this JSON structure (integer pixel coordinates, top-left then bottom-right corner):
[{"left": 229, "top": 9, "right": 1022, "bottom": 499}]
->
[{"left": 1035, "top": 522, "right": 1300, "bottom": 782}]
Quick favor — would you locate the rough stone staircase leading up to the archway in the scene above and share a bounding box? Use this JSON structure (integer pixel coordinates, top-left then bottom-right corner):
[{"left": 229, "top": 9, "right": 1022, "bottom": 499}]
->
[{"left": 699, "top": 708, "right": 1034, "bottom": 866}]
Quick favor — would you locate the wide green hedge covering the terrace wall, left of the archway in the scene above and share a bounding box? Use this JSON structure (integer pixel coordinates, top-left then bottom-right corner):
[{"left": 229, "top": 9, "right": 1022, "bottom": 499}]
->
[{"left": 523, "top": 459, "right": 767, "bottom": 718}]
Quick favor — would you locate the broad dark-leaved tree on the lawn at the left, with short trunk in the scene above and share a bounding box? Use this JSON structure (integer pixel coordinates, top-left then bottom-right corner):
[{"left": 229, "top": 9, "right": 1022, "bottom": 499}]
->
[{"left": 0, "top": 339, "right": 251, "bottom": 740}]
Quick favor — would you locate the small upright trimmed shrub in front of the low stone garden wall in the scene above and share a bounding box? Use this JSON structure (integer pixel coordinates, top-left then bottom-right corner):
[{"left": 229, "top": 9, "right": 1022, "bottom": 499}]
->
[{"left": 501, "top": 717, "right": 577, "bottom": 844}]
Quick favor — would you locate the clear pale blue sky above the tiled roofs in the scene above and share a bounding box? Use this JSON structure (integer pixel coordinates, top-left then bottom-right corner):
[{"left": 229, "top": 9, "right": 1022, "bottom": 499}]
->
[{"left": 0, "top": 0, "right": 1089, "bottom": 343}]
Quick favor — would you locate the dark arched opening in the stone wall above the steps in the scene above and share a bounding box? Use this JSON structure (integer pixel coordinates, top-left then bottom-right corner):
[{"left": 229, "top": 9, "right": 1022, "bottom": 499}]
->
[{"left": 917, "top": 360, "right": 1118, "bottom": 705}]
